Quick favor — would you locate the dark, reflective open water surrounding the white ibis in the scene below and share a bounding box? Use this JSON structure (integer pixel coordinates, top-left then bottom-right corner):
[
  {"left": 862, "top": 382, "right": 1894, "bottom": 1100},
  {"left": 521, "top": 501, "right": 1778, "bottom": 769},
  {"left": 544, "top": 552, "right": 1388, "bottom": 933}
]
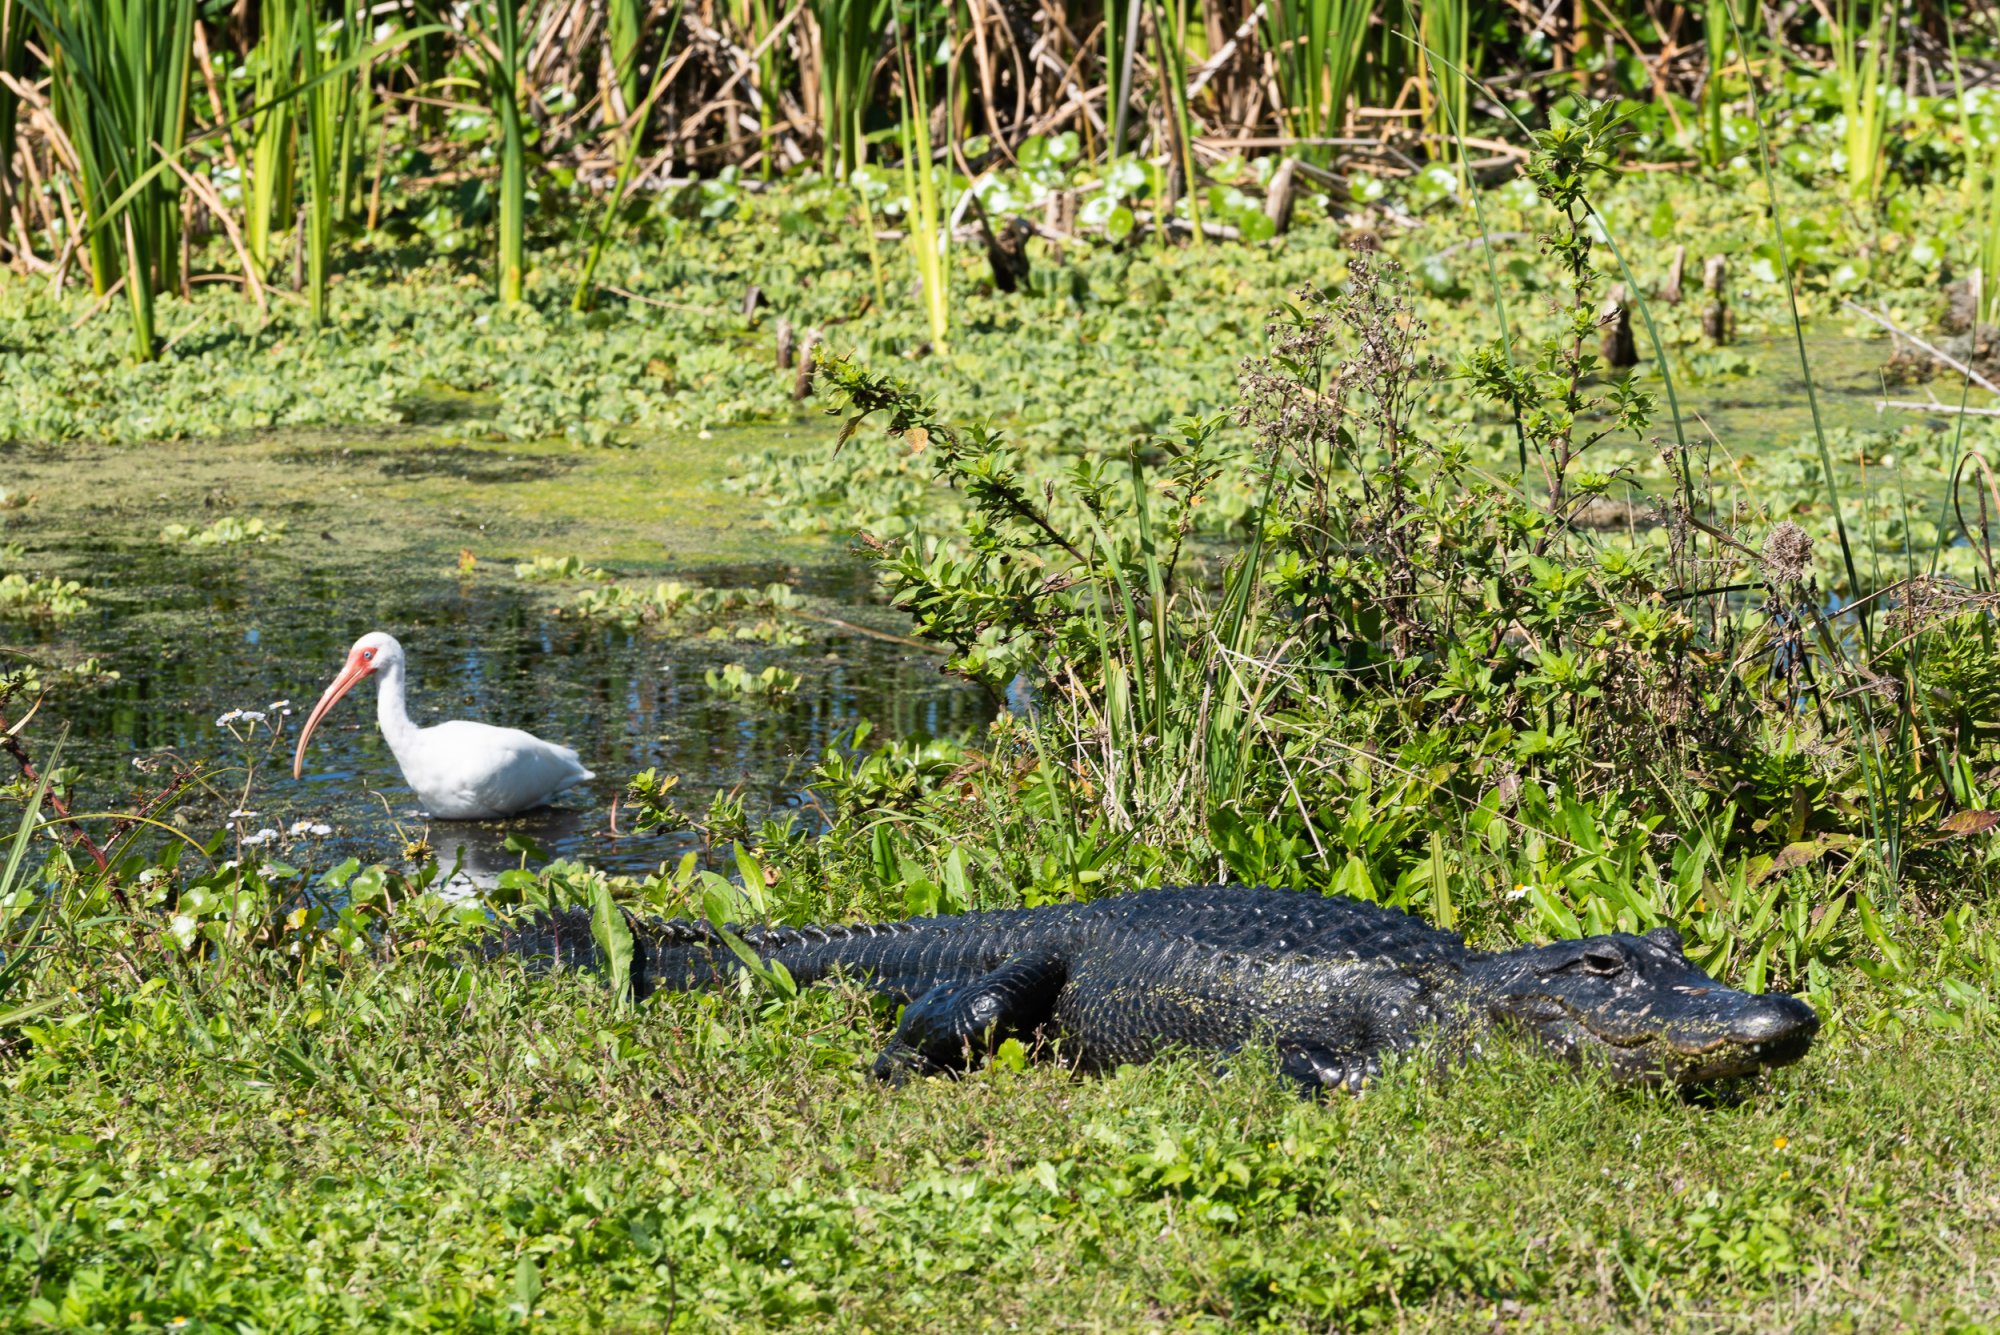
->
[{"left": 47, "top": 562, "right": 990, "bottom": 877}]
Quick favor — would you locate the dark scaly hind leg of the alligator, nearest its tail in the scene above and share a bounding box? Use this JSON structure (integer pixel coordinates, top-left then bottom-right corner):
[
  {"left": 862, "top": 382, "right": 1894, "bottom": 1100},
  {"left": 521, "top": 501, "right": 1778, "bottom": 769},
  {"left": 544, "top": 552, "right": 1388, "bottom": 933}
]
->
[{"left": 874, "top": 957, "right": 1070, "bottom": 1083}]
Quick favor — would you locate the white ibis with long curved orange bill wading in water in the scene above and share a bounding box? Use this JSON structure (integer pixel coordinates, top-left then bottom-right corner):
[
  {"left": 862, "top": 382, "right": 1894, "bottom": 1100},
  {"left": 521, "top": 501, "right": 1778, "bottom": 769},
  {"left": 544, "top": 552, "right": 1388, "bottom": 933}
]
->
[{"left": 292, "top": 632, "right": 596, "bottom": 821}]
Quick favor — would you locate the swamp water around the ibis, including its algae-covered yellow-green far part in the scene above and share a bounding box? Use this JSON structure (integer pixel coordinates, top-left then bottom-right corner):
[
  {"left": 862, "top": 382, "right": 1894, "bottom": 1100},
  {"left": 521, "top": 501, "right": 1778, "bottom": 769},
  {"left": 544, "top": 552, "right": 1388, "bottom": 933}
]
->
[{"left": 6, "top": 432, "right": 992, "bottom": 885}]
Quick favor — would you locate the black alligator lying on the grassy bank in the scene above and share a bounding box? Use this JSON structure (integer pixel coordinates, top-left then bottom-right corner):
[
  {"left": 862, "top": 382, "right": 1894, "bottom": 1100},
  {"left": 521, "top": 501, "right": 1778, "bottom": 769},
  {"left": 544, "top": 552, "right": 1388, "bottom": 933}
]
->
[{"left": 500, "top": 885, "right": 1820, "bottom": 1091}]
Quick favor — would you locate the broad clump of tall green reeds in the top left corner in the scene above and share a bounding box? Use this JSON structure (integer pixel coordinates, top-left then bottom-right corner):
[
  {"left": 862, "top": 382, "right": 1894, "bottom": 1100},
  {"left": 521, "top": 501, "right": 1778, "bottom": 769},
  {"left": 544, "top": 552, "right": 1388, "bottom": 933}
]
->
[{"left": 26, "top": 0, "right": 194, "bottom": 362}]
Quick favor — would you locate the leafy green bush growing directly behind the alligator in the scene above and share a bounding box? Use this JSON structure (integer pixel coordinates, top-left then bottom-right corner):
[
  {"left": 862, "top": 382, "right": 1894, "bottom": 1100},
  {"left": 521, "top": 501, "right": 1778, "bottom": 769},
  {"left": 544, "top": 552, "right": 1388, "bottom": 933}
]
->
[{"left": 788, "top": 106, "right": 2000, "bottom": 987}]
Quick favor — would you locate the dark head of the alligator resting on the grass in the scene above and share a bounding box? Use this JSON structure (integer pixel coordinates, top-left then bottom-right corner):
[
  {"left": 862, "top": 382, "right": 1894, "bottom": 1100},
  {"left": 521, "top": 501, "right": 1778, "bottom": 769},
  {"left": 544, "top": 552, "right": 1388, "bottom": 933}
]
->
[{"left": 1480, "top": 927, "right": 1820, "bottom": 1085}]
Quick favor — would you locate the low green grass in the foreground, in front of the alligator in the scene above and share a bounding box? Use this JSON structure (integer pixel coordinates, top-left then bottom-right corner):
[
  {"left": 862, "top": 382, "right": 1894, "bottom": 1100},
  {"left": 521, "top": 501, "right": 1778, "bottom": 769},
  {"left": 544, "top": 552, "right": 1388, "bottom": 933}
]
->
[{"left": 0, "top": 957, "right": 2000, "bottom": 1331}]
